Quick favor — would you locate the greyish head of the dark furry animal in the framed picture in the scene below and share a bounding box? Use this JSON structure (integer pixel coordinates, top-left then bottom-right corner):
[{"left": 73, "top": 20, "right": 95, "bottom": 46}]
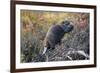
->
[{"left": 61, "top": 20, "right": 74, "bottom": 33}]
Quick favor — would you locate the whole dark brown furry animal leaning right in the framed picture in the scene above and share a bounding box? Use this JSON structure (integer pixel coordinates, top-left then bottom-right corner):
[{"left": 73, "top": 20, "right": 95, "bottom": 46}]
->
[{"left": 43, "top": 20, "right": 74, "bottom": 54}]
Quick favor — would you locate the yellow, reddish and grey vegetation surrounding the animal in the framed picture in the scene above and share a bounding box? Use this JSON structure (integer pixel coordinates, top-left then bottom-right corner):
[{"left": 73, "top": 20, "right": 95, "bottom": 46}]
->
[{"left": 20, "top": 10, "right": 90, "bottom": 63}]
